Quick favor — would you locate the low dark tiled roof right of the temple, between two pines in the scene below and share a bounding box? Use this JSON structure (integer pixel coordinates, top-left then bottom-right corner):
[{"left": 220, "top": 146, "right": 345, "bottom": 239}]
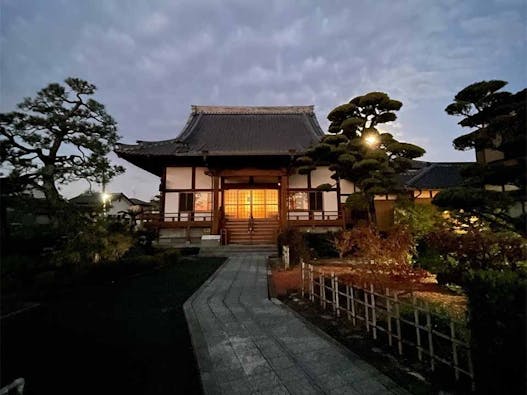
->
[{"left": 403, "top": 162, "right": 473, "bottom": 189}]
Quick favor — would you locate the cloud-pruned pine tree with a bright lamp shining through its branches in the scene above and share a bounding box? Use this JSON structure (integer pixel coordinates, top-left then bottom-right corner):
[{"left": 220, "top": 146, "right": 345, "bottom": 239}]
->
[{"left": 297, "top": 92, "right": 425, "bottom": 222}]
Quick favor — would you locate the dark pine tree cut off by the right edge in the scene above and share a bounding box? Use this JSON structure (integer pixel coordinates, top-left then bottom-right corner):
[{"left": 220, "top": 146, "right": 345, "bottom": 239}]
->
[{"left": 434, "top": 80, "right": 527, "bottom": 233}]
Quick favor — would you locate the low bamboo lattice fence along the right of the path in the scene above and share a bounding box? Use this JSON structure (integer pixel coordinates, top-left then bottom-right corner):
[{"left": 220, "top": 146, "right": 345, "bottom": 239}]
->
[{"left": 301, "top": 262, "right": 474, "bottom": 390}]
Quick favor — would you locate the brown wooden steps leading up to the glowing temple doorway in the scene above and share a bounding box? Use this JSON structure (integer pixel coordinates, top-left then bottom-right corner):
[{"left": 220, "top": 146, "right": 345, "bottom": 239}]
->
[{"left": 225, "top": 219, "right": 278, "bottom": 245}]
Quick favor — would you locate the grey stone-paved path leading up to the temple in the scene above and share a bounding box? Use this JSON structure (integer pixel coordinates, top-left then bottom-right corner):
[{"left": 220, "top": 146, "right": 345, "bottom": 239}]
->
[{"left": 185, "top": 253, "right": 406, "bottom": 395}]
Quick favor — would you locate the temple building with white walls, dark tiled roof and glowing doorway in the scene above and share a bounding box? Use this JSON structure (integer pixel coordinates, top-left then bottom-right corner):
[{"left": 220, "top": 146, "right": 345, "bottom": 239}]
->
[{"left": 116, "top": 106, "right": 470, "bottom": 244}]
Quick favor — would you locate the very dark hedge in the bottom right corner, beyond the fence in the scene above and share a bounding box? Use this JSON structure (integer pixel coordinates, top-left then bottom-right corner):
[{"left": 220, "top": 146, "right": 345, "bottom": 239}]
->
[{"left": 464, "top": 270, "right": 527, "bottom": 394}]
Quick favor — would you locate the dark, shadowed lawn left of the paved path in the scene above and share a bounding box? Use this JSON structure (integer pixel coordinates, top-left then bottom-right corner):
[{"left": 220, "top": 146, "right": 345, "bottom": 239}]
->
[{"left": 1, "top": 258, "right": 223, "bottom": 395}]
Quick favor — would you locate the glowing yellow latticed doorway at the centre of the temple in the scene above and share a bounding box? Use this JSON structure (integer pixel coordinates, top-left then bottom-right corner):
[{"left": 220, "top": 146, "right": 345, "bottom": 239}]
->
[{"left": 223, "top": 189, "right": 278, "bottom": 219}]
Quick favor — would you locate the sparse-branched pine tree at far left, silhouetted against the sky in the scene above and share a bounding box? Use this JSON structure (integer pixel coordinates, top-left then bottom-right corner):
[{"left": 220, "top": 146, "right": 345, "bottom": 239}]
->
[{"left": 0, "top": 78, "right": 124, "bottom": 206}]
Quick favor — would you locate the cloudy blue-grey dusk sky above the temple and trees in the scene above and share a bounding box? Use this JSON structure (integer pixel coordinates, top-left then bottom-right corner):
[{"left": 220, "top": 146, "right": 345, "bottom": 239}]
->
[{"left": 0, "top": 0, "right": 527, "bottom": 199}]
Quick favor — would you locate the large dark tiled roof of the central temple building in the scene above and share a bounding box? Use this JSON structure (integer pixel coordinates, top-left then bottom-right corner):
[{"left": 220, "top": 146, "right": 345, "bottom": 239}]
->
[{"left": 115, "top": 106, "right": 324, "bottom": 175}]
